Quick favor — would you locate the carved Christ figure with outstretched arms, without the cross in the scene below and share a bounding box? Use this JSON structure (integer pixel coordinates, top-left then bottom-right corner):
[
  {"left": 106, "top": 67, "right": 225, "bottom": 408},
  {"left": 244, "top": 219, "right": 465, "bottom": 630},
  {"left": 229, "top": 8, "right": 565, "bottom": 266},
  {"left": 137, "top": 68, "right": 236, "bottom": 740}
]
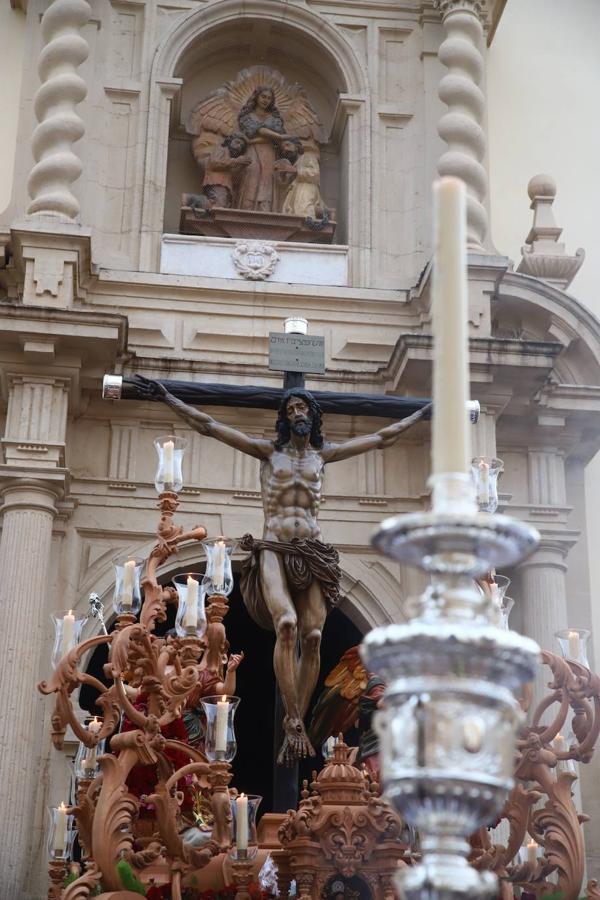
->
[{"left": 139, "top": 378, "right": 430, "bottom": 765}]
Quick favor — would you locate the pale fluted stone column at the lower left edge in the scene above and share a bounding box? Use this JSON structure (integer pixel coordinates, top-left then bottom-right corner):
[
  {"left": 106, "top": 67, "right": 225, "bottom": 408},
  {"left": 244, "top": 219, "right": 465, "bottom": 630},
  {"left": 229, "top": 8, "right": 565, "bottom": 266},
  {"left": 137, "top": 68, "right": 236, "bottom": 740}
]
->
[{"left": 0, "top": 478, "right": 60, "bottom": 900}]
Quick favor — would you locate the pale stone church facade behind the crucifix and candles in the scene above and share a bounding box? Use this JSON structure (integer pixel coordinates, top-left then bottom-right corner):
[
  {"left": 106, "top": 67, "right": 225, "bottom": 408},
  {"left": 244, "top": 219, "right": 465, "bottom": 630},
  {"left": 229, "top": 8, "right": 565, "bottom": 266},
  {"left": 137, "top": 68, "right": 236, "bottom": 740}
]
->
[{"left": 0, "top": 0, "right": 600, "bottom": 900}]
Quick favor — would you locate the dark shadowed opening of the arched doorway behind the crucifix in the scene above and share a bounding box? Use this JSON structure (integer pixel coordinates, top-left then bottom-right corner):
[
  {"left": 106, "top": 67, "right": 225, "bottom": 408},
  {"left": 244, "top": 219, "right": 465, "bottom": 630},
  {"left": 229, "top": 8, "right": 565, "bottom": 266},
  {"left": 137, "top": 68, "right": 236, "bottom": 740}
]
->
[{"left": 79, "top": 567, "right": 362, "bottom": 813}]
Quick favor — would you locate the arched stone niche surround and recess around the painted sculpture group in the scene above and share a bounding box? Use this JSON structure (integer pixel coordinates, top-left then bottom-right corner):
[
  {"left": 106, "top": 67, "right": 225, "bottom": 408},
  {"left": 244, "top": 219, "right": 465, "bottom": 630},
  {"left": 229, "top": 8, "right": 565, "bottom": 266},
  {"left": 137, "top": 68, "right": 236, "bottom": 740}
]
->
[{"left": 140, "top": 0, "right": 370, "bottom": 284}]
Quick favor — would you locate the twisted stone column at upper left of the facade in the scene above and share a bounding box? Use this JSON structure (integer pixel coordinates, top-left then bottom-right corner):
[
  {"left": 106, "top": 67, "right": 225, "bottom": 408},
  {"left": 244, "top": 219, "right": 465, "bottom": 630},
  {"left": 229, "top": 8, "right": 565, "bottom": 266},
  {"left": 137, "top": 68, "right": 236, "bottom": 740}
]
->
[{"left": 27, "top": 0, "right": 91, "bottom": 219}]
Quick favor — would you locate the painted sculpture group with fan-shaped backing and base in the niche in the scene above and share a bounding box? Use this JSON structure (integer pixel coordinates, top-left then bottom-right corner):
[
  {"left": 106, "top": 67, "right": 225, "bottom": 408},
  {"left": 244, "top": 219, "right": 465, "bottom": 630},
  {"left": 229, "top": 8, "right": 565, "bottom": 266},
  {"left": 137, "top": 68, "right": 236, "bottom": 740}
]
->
[{"left": 180, "top": 66, "right": 335, "bottom": 243}]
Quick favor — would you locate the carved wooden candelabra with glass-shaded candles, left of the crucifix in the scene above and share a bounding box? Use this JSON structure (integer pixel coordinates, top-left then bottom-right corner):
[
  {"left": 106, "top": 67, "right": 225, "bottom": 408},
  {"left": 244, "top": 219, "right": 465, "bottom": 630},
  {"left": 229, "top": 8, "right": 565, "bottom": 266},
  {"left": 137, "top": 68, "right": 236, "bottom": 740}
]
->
[{"left": 39, "top": 436, "right": 252, "bottom": 900}]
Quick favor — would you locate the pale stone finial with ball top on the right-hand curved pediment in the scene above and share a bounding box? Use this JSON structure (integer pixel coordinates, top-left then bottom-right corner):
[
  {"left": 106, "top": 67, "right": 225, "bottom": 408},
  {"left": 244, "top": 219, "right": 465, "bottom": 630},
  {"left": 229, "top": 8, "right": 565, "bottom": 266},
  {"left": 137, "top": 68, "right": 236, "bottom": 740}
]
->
[{"left": 517, "top": 175, "right": 585, "bottom": 290}]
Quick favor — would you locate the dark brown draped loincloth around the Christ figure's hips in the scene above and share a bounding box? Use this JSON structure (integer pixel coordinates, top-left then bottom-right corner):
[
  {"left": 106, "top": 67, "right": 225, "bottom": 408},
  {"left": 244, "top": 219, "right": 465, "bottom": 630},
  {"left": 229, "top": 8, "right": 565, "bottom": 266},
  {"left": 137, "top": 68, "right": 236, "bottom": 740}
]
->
[{"left": 239, "top": 534, "right": 342, "bottom": 631}]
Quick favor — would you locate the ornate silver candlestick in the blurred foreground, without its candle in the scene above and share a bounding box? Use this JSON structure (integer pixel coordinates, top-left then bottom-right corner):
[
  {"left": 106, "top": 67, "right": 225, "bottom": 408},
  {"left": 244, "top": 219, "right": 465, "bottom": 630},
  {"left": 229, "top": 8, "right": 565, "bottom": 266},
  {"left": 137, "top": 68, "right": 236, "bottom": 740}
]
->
[{"left": 362, "top": 473, "right": 539, "bottom": 900}]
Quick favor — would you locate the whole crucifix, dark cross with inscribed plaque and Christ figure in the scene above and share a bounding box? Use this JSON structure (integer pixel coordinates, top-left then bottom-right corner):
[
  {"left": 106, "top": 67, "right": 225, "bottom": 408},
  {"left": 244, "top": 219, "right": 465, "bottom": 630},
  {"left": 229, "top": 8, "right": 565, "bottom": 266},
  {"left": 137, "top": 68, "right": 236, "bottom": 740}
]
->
[{"left": 104, "top": 319, "right": 476, "bottom": 809}]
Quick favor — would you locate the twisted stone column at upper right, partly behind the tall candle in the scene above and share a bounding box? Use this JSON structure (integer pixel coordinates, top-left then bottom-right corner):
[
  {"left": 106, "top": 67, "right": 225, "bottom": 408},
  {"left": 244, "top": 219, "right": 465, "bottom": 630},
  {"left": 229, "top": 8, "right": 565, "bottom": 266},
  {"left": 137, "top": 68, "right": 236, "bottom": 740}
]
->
[{"left": 436, "top": 0, "right": 488, "bottom": 251}]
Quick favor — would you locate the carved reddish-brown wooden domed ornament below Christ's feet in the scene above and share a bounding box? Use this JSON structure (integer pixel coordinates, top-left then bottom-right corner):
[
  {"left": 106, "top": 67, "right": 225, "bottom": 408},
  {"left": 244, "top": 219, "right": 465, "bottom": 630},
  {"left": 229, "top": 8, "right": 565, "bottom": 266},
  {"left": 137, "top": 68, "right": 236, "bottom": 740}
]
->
[{"left": 273, "top": 740, "right": 409, "bottom": 900}]
